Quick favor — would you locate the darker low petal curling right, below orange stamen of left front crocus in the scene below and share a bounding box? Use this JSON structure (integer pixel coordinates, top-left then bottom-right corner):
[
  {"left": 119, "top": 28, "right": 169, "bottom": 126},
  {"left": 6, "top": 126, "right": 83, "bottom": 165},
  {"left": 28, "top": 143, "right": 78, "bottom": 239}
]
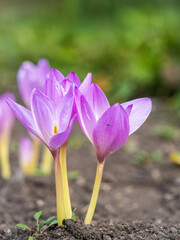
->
[{"left": 49, "top": 115, "right": 76, "bottom": 151}]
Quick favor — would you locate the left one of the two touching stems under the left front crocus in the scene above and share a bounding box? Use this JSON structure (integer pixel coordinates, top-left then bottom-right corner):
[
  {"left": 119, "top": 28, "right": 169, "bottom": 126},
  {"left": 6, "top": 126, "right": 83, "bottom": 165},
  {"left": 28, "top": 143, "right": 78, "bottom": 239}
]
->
[{"left": 54, "top": 150, "right": 65, "bottom": 226}]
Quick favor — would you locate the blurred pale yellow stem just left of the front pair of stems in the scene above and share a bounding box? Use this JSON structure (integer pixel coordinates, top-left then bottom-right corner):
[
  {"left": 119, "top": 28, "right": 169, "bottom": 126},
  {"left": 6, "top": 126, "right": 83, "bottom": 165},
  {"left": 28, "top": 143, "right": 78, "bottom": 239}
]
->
[{"left": 41, "top": 147, "right": 52, "bottom": 175}]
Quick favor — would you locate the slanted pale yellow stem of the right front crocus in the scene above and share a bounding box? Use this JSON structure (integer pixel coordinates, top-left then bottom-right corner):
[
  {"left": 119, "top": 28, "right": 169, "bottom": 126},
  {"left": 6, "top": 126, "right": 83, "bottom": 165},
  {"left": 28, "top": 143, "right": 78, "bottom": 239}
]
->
[{"left": 84, "top": 161, "right": 104, "bottom": 224}]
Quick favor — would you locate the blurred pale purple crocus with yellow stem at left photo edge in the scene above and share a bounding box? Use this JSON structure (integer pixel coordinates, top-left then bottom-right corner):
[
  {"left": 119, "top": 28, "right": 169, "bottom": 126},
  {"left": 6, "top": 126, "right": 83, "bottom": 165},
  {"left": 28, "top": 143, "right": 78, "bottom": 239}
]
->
[{"left": 0, "top": 93, "right": 15, "bottom": 179}]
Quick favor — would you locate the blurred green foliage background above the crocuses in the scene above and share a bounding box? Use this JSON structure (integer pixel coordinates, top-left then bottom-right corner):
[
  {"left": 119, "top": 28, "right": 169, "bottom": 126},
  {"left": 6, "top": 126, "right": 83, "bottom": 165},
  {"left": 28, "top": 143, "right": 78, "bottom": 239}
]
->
[{"left": 0, "top": 0, "right": 180, "bottom": 105}]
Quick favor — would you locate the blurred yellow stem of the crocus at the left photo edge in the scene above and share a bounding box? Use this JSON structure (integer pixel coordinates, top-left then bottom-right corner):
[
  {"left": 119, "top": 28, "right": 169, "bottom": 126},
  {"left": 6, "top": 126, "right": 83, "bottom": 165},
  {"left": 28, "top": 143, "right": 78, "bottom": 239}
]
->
[{"left": 0, "top": 136, "right": 11, "bottom": 179}]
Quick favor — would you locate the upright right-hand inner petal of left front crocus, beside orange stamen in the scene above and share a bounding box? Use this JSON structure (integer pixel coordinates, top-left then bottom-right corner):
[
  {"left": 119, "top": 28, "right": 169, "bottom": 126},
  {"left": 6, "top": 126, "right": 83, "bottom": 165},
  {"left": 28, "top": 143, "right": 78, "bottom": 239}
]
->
[{"left": 56, "top": 84, "right": 74, "bottom": 132}]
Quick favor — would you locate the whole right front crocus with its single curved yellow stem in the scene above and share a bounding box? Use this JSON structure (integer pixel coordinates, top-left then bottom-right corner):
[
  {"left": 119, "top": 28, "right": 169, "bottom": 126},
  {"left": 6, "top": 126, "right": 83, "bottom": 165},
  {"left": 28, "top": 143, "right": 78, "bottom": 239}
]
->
[{"left": 76, "top": 84, "right": 152, "bottom": 224}]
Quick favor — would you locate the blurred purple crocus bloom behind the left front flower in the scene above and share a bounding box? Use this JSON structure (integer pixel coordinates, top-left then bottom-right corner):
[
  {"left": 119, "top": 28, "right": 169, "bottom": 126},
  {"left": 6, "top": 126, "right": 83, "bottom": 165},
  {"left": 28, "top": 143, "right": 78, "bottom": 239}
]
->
[{"left": 17, "top": 59, "right": 50, "bottom": 108}]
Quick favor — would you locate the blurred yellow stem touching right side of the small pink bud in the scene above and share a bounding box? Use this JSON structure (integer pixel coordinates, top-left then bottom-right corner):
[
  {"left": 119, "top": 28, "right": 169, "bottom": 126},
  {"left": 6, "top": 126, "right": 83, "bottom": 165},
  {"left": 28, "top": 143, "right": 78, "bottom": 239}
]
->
[{"left": 26, "top": 137, "right": 40, "bottom": 174}]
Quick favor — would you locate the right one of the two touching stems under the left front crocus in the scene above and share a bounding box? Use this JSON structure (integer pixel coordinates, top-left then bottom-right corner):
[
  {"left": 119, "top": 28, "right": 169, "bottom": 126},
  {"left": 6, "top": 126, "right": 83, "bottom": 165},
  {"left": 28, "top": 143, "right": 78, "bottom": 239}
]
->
[{"left": 60, "top": 143, "right": 72, "bottom": 219}]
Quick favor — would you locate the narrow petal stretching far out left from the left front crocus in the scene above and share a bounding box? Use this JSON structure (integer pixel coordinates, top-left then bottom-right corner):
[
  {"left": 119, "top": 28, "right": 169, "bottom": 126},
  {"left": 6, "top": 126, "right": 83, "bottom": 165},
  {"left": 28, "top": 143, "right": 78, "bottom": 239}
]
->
[{"left": 6, "top": 98, "right": 44, "bottom": 142}]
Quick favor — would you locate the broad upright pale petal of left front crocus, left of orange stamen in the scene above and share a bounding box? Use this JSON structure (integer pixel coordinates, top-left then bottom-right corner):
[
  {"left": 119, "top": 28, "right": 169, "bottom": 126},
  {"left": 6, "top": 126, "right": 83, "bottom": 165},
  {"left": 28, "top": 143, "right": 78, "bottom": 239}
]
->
[{"left": 31, "top": 88, "right": 55, "bottom": 144}]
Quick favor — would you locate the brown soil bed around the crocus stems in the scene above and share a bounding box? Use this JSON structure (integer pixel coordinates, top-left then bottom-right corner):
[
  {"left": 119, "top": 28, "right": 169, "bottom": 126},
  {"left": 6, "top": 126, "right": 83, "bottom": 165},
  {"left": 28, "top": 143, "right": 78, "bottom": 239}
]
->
[{"left": 0, "top": 100, "right": 180, "bottom": 240}]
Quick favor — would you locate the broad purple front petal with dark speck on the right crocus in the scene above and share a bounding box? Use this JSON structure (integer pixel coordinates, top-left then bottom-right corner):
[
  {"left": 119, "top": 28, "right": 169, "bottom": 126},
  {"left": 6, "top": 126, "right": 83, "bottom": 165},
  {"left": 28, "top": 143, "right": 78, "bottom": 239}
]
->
[{"left": 93, "top": 103, "right": 129, "bottom": 162}]
